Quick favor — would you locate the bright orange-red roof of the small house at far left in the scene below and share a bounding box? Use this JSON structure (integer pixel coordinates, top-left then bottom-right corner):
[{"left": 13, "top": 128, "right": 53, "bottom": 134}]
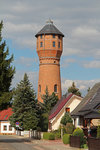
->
[{"left": 0, "top": 108, "right": 13, "bottom": 120}]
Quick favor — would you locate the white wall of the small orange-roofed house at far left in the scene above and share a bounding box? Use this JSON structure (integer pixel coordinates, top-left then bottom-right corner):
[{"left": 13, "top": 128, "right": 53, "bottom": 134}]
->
[{"left": 0, "top": 121, "right": 15, "bottom": 134}]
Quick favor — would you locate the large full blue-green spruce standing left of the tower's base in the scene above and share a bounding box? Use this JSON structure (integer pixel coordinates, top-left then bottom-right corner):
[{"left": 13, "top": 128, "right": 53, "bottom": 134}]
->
[{"left": 10, "top": 73, "right": 38, "bottom": 130}]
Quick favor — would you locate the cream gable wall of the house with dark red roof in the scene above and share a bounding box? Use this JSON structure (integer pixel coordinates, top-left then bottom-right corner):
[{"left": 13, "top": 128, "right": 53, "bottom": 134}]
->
[{"left": 49, "top": 96, "right": 82, "bottom": 130}]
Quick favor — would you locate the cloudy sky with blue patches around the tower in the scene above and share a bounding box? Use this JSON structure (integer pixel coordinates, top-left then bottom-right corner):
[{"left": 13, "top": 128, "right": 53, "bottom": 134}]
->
[{"left": 0, "top": 0, "right": 100, "bottom": 96}]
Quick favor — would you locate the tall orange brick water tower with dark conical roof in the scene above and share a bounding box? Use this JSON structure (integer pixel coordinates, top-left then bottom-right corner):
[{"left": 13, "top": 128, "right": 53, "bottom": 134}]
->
[{"left": 35, "top": 20, "right": 64, "bottom": 102}]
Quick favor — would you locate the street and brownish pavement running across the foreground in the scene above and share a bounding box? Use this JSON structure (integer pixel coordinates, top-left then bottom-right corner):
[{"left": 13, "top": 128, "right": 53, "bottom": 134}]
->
[{"left": 0, "top": 135, "right": 85, "bottom": 150}]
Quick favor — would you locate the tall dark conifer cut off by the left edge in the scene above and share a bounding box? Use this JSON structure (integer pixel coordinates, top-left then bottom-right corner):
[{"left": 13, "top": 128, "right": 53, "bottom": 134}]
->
[{"left": 0, "top": 21, "right": 15, "bottom": 109}]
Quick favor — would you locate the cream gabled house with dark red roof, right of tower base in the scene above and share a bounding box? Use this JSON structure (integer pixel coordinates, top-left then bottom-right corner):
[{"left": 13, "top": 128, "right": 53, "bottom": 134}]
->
[{"left": 48, "top": 93, "right": 82, "bottom": 131}]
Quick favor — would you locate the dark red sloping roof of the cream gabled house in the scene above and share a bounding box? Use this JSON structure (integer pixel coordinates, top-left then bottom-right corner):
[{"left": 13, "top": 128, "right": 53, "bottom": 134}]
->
[{"left": 49, "top": 93, "right": 73, "bottom": 120}]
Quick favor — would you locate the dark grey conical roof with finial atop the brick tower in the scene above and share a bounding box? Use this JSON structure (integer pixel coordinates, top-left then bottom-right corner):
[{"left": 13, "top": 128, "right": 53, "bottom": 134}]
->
[{"left": 35, "top": 19, "right": 64, "bottom": 37}]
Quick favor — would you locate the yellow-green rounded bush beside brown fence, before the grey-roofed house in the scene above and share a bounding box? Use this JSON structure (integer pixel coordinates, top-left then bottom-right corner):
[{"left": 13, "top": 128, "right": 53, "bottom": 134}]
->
[{"left": 73, "top": 128, "right": 86, "bottom": 145}]
